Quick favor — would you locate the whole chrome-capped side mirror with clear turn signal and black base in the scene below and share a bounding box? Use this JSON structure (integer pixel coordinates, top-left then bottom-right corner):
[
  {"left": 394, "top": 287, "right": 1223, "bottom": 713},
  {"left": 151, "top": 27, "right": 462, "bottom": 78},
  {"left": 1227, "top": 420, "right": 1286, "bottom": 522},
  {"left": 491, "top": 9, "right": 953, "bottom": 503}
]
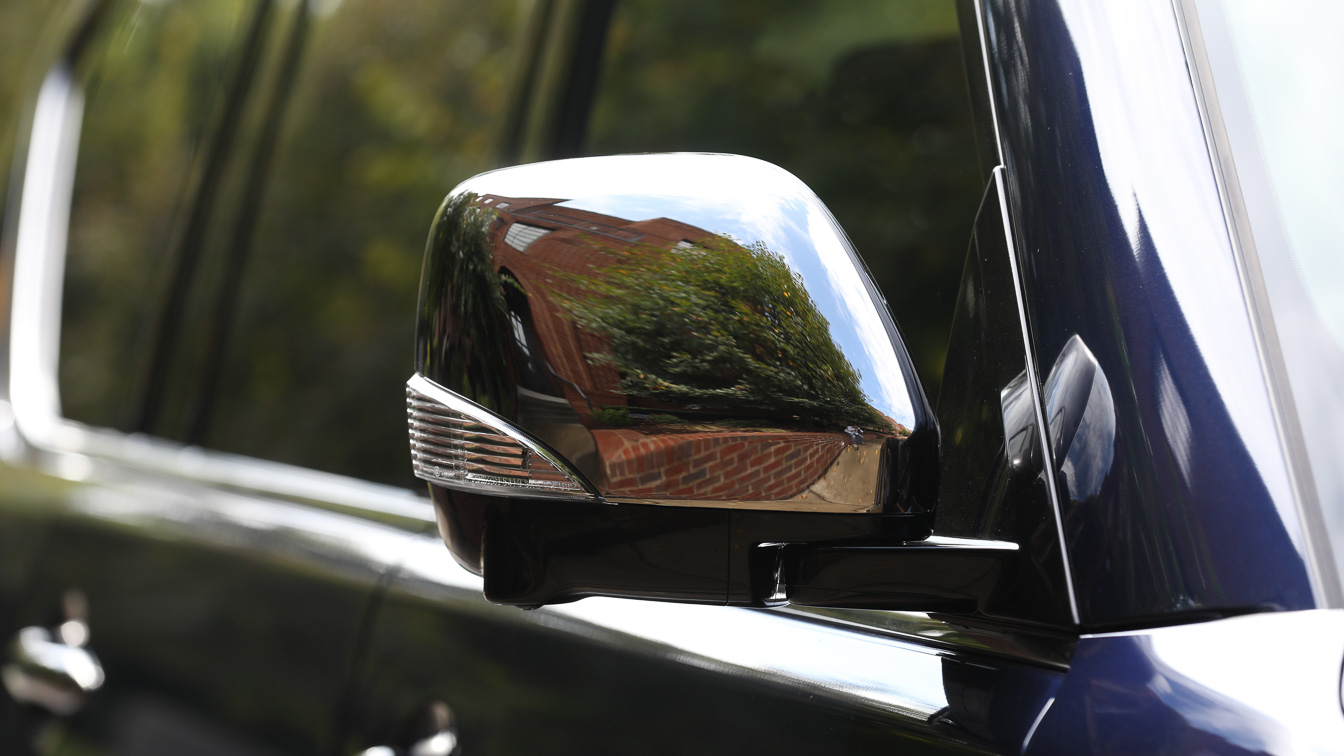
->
[{"left": 407, "top": 155, "right": 1003, "bottom": 609}]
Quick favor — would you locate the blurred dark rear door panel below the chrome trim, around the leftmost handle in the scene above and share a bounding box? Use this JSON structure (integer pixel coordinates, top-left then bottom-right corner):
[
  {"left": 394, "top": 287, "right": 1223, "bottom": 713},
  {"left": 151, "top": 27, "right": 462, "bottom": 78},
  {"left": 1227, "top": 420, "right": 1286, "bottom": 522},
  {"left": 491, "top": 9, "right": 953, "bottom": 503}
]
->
[{"left": 0, "top": 463, "right": 406, "bottom": 755}]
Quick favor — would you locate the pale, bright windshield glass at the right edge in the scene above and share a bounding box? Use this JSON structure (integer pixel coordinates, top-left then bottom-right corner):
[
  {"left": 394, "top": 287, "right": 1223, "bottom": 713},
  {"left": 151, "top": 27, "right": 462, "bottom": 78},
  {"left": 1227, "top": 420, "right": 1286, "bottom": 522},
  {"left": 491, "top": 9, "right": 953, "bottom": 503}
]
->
[{"left": 1198, "top": 0, "right": 1344, "bottom": 589}]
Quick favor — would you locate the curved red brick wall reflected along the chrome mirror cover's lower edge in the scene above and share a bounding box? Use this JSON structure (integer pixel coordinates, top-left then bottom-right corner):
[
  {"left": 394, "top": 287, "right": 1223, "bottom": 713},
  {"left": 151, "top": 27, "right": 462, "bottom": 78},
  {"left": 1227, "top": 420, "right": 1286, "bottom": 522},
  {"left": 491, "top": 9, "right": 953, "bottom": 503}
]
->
[{"left": 593, "top": 429, "right": 847, "bottom": 500}]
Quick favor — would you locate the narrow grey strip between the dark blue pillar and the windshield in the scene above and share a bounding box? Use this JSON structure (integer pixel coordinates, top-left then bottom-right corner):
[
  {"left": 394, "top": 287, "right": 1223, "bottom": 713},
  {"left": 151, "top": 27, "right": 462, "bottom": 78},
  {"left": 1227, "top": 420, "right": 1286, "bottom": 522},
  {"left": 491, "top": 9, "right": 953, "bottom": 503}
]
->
[{"left": 1172, "top": 0, "right": 1344, "bottom": 608}]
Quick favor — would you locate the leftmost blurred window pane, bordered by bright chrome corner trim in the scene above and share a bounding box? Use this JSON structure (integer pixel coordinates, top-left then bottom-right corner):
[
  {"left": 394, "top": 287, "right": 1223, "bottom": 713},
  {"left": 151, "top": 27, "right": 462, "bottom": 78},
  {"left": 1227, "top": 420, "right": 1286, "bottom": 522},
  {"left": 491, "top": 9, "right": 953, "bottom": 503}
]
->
[{"left": 59, "top": 0, "right": 257, "bottom": 428}]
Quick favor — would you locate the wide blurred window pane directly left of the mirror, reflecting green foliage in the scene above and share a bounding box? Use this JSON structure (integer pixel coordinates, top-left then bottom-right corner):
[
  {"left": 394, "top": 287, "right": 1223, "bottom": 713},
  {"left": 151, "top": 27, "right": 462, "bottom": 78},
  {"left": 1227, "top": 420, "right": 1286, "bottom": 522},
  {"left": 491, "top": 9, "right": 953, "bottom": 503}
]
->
[{"left": 202, "top": 0, "right": 521, "bottom": 484}]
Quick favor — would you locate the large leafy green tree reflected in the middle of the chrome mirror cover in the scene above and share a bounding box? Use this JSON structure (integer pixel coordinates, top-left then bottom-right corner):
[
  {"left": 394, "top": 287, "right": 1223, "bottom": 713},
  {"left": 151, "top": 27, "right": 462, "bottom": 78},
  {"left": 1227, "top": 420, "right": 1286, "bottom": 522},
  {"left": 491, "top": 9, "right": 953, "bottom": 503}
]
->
[{"left": 560, "top": 237, "right": 891, "bottom": 429}]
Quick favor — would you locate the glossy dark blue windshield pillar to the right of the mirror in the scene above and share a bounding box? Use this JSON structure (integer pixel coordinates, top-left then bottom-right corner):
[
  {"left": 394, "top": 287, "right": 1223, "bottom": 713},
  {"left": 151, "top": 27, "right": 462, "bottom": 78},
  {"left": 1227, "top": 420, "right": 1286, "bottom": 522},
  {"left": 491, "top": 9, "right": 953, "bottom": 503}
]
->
[{"left": 985, "top": 0, "right": 1314, "bottom": 626}]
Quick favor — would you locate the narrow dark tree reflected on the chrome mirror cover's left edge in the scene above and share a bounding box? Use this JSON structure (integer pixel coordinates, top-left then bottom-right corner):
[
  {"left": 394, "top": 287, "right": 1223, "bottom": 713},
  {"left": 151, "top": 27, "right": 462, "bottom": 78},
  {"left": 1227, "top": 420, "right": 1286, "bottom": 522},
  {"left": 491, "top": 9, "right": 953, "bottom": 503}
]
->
[{"left": 419, "top": 192, "right": 513, "bottom": 414}]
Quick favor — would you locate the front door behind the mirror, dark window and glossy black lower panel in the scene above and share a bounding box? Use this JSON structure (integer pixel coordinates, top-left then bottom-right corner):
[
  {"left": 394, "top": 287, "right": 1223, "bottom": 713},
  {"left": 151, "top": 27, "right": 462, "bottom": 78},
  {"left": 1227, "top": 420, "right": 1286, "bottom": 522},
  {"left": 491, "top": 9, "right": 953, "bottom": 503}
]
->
[{"left": 333, "top": 1, "right": 1073, "bottom": 753}]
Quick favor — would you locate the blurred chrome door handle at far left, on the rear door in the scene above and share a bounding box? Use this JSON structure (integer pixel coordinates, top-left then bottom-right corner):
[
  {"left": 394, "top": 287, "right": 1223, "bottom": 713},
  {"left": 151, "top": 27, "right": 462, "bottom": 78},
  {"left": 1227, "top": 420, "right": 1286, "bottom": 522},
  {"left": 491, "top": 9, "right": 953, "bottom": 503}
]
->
[{"left": 0, "top": 620, "right": 103, "bottom": 716}]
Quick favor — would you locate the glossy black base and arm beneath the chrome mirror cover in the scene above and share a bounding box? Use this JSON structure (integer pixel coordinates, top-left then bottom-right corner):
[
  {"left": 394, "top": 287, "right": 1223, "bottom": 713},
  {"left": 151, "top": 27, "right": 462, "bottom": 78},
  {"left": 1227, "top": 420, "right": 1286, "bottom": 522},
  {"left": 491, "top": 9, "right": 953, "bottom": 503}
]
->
[{"left": 434, "top": 490, "right": 1017, "bottom": 613}]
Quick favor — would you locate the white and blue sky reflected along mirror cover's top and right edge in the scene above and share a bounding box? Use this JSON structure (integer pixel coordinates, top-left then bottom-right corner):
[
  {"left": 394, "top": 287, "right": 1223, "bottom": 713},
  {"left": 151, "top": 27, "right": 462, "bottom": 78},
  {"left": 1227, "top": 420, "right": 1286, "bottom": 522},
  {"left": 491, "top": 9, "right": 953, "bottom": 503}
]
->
[{"left": 499, "top": 155, "right": 914, "bottom": 428}]
